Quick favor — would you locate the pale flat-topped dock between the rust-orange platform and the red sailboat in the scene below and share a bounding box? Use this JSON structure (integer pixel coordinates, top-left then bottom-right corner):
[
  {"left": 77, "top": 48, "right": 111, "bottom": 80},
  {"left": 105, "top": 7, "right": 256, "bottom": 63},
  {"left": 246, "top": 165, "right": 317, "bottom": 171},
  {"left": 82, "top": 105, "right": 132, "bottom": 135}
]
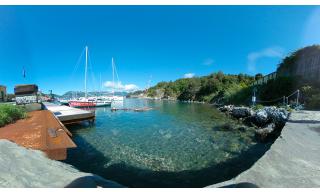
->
[{"left": 43, "top": 102, "right": 95, "bottom": 125}]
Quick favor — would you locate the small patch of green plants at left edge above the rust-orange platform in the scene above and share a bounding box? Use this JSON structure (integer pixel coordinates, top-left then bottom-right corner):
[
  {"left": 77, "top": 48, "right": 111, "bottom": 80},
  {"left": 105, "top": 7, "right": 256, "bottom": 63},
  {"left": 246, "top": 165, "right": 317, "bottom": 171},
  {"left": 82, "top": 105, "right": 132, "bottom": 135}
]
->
[{"left": 0, "top": 104, "right": 27, "bottom": 127}]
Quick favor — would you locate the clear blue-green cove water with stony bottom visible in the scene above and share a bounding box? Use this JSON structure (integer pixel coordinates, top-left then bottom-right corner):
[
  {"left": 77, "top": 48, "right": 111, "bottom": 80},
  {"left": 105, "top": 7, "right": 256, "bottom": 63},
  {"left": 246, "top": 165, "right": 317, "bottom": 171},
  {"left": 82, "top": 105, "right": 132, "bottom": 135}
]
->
[{"left": 66, "top": 99, "right": 268, "bottom": 187}]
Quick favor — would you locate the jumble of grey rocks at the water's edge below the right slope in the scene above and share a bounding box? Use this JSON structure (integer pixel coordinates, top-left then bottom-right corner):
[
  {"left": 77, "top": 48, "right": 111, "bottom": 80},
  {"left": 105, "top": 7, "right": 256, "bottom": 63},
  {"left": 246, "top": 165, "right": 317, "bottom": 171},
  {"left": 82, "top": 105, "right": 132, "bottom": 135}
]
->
[{"left": 218, "top": 105, "right": 290, "bottom": 142}]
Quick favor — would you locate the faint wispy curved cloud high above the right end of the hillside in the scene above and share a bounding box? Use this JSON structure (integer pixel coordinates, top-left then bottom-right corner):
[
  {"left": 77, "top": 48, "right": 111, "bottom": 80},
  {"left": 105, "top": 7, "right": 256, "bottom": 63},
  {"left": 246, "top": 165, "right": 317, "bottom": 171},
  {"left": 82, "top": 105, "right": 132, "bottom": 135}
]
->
[{"left": 247, "top": 47, "right": 284, "bottom": 73}]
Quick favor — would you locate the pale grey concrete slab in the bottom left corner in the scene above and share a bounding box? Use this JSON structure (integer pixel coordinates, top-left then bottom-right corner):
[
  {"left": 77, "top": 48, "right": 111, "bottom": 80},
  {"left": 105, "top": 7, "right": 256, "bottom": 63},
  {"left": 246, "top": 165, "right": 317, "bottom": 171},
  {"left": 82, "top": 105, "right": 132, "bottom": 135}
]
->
[{"left": 0, "top": 140, "right": 121, "bottom": 188}]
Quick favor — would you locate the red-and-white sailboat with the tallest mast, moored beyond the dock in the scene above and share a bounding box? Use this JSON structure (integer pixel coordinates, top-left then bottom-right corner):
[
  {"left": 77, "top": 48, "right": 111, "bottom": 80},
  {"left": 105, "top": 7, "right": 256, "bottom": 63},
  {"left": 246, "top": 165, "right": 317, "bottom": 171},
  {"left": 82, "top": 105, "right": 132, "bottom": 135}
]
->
[{"left": 68, "top": 46, "right": 111, "bottom": 107}]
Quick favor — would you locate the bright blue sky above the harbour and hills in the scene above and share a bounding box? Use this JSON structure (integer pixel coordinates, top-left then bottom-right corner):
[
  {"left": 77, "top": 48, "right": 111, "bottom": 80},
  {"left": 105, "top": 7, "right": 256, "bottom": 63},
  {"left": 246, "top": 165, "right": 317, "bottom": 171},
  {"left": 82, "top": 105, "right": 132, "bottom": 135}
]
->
[{"left": 0, "top": 6, "right": 320, "bottom": 94}]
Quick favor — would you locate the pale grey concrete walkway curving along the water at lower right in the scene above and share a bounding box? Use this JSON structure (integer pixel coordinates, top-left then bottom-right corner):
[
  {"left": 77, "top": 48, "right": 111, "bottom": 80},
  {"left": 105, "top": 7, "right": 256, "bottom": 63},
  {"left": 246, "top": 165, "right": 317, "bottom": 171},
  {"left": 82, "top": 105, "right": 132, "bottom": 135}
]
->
[{"left": 208, "top": 111, "right": 320, "bottom": 188}]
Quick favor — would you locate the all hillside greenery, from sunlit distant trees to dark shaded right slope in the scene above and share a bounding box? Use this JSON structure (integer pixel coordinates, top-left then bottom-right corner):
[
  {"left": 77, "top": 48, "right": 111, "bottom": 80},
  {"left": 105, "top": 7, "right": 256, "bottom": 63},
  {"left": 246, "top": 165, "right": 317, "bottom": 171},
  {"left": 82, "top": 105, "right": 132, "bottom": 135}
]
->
[{"left": 133, "top": 45, "right": 320, "bottom": 109}]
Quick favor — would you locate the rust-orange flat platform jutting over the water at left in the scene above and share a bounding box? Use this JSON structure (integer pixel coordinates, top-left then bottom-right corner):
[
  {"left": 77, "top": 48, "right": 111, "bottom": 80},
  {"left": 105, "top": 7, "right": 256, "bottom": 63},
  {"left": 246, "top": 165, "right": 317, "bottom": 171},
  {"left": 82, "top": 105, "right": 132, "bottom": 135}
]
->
[{"left": 0, "top": 110, "right": 76, "bottom": 160}]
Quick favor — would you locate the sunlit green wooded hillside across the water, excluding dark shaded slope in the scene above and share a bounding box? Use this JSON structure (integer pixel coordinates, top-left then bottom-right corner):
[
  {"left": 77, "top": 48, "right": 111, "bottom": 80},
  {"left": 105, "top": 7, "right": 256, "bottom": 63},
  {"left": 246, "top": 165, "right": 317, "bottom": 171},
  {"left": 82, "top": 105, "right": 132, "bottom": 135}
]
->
[{"left": 146, "top": 72, "right": 255, "bottom": 104}]
